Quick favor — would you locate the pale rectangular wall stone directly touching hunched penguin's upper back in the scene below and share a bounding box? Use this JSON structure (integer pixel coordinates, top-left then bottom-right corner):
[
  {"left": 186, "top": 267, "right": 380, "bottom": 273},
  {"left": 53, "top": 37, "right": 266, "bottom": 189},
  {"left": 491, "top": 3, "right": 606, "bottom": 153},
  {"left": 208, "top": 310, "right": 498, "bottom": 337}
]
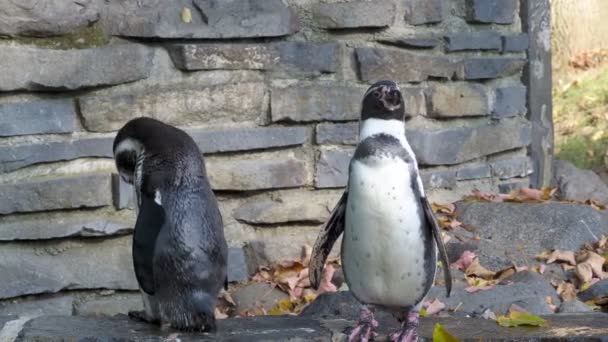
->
[{"left": 207, "top": 156, "right": 312, "bottom": 191}]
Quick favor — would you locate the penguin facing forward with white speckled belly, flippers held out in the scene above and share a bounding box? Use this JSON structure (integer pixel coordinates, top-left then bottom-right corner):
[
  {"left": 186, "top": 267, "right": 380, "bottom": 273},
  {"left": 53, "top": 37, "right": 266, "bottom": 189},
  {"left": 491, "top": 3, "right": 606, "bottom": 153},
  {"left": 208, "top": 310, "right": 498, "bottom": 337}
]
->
[{"left": 310, "top": 81, "right": 452, "bottom": 342}]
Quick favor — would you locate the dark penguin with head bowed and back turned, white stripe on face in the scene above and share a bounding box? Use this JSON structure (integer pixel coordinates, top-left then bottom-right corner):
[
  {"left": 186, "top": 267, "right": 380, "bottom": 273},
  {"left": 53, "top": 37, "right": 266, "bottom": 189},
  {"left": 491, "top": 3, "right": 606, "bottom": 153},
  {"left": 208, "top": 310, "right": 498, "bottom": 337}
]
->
[{"left": 113, "top": 117, "right": 228, "bottom": 331}]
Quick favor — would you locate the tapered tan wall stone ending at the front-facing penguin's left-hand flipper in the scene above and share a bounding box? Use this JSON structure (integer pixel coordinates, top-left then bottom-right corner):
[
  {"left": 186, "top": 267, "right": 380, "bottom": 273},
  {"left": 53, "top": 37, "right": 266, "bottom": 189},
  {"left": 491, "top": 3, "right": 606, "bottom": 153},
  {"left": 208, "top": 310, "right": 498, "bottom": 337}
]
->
[{"left": 233, "top": 191, "right": 340, "bottom": 224}]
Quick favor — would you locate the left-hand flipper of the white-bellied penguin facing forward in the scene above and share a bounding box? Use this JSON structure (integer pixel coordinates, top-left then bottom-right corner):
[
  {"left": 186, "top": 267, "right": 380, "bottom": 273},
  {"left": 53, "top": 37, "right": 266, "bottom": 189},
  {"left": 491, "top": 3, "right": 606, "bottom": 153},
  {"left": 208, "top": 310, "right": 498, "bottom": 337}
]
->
[{"left": 308, "top": 191, "right": 348, "bottom": 289}]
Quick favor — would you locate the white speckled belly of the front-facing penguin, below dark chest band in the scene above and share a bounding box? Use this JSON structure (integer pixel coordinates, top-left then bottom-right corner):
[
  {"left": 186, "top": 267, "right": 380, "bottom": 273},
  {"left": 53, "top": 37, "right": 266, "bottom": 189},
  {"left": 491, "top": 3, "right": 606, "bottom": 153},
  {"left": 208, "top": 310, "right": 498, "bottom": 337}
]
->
[{"left": 342, "top": 157, "right": 434, "bottom": 307}]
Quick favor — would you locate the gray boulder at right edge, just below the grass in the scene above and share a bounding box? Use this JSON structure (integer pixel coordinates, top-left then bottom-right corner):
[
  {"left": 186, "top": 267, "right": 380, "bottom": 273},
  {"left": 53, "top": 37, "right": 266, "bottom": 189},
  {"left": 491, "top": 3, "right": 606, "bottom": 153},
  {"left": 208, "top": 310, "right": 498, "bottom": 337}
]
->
[{"left": 552, "top": 160, "right": 608, "bottom": 204}]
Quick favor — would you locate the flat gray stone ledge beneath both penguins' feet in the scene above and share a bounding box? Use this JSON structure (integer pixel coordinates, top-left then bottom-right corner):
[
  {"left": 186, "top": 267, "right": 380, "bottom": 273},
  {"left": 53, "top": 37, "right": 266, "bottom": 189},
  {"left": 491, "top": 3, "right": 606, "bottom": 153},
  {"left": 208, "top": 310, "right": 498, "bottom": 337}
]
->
[{"left": 0, "top": 313, "right": 608, "bottom": 342}]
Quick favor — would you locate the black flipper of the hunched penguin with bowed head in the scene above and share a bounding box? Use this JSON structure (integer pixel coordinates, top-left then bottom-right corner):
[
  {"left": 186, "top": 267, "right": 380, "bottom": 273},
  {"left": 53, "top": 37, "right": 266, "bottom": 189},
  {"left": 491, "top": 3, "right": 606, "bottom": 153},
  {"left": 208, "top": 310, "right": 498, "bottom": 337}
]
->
[{"left": 133, "top": 193, "right": 165, "bottom": 295}]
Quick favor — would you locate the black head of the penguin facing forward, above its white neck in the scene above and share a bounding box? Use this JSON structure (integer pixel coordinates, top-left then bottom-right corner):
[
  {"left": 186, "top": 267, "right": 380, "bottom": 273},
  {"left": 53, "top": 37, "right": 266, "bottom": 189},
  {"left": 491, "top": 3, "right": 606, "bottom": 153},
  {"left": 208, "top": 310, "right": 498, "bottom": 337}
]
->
[{"left": 361, "top": 81, "right": 405, "bottom": 121}]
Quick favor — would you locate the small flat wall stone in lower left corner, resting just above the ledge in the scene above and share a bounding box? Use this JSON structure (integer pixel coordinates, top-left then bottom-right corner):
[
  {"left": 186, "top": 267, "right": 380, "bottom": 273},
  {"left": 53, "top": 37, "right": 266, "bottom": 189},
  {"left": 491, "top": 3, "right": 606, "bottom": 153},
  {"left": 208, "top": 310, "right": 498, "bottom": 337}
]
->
[{"left": 0, "top": 295, "right": 74, "bottom": 316}]
